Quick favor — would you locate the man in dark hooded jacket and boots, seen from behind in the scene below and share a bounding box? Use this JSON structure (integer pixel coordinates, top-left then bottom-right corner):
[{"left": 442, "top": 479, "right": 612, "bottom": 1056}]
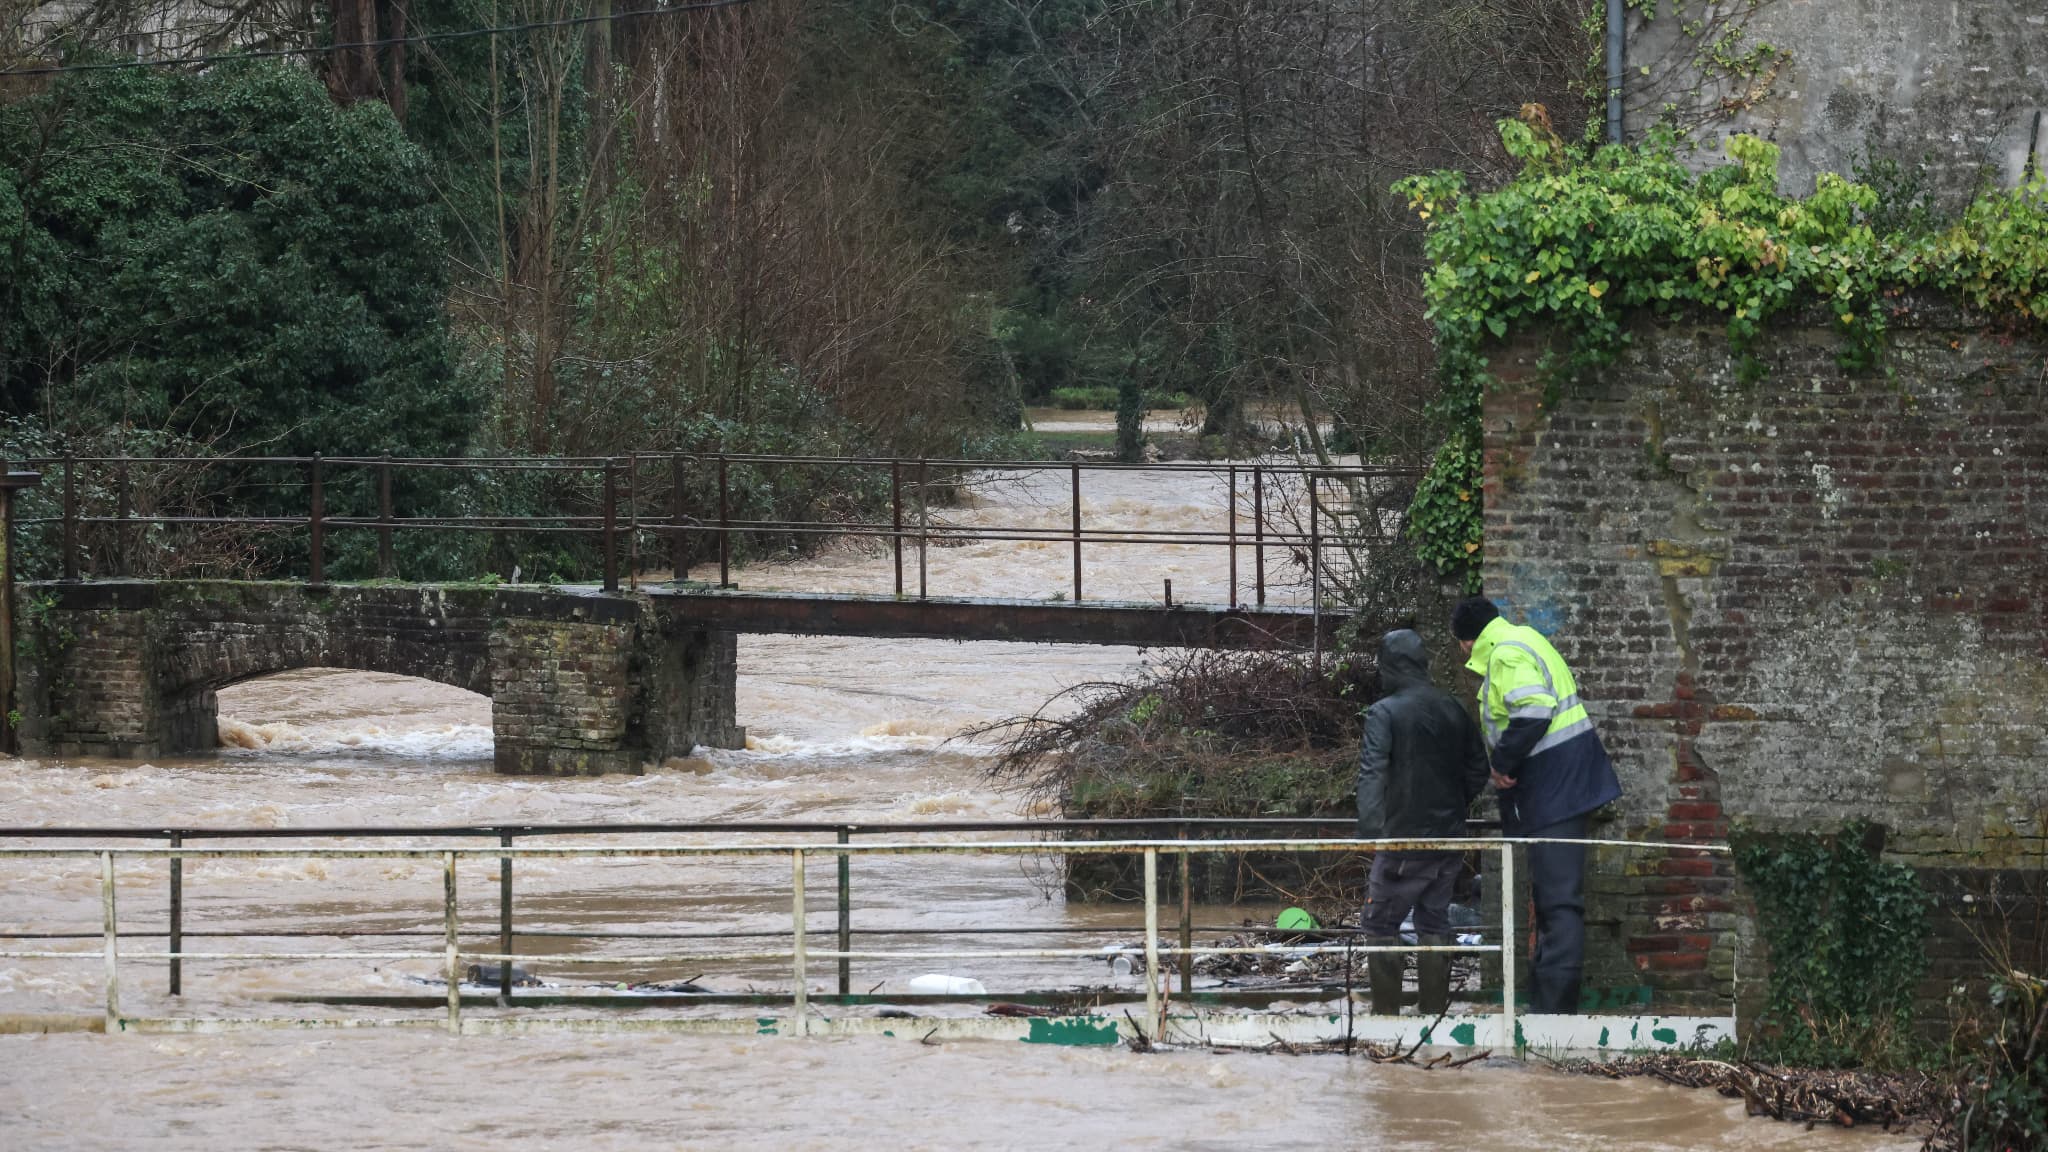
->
[{"left": 1358, "top": 629, "right": 1487, "bottom": 1017}]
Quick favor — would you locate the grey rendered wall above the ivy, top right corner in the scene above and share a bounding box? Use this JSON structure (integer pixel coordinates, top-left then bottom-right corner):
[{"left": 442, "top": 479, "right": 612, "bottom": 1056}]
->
[{"left": 1628, "top": 0, "right": 2048, "bottom": 205}]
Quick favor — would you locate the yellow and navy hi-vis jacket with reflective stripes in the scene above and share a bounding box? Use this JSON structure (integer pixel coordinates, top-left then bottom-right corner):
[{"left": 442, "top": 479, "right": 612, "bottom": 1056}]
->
[{"left": 1466, "top": 619, "right": 1622, "bottom": 830}]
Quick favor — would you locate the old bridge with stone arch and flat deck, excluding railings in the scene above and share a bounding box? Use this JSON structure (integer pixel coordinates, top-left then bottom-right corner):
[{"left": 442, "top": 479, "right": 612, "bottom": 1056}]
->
[{"left": 14, "top": 580, "right": 1337, "bottom": 775}]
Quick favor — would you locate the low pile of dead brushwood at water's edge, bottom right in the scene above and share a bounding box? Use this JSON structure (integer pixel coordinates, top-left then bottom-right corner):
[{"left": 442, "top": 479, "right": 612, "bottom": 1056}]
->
[{"left": 1563, "top": 1054, "right": 1948, "bottom": 1132}]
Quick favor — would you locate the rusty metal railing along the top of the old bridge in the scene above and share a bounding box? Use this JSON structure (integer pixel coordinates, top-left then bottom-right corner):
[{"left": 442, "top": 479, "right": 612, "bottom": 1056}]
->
[{"left": 14, "top": 453, "right": 1419, "bottom": 607}]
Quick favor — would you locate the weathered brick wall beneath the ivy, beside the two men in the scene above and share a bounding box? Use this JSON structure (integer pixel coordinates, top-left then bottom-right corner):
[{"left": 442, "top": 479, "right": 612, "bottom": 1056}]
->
[{"left": 1485, "top": 305, "right": 2048, "bottom": 1006}]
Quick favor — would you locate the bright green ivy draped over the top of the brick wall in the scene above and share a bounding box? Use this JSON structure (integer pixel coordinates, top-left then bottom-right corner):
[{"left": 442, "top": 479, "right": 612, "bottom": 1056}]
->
[{"left": 1399, "top": 121, "right": 2048, "bottom": 580}]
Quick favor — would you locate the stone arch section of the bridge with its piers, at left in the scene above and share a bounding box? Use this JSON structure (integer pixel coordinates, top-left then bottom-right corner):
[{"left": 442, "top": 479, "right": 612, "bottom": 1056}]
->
[{"left": 16, "top": 580, "right": 745, "bottom": 775}]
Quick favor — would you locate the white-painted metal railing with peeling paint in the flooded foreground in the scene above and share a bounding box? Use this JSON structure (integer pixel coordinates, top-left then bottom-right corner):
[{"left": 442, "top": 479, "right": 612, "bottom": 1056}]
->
[{"left": 0, "top": 838, "right": 1729, "bottom": 1037}]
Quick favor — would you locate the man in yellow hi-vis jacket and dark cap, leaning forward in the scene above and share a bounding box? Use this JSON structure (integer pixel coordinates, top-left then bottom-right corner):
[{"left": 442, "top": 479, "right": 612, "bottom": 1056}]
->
[{"left": 1450, "top": 596, "right": 1622, "bottom": 1013}]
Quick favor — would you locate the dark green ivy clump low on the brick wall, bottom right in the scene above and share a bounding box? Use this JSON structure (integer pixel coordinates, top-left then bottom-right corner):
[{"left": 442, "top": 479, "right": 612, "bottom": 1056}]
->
[{"left": 1733, "top": 822, "right": 1929, "bottom": 1066}]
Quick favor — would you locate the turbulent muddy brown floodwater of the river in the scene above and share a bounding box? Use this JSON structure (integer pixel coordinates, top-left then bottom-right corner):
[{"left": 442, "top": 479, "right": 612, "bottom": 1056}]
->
[{"left": 0, "top": 434, "right": 1911, "bottom": 1152}]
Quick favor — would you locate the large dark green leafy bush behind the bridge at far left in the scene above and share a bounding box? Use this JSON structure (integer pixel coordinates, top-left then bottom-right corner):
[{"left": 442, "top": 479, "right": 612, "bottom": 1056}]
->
[{"left": 0, "top": 64, "right": 475, "bottom": 455}]
